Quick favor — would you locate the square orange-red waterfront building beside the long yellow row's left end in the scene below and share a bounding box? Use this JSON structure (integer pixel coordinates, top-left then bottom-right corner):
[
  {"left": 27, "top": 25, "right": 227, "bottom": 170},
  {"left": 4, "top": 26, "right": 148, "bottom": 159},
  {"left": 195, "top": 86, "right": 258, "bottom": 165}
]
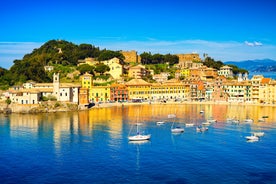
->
[{"left": 110, "top": 84, "right": 128, "bottom": 102}]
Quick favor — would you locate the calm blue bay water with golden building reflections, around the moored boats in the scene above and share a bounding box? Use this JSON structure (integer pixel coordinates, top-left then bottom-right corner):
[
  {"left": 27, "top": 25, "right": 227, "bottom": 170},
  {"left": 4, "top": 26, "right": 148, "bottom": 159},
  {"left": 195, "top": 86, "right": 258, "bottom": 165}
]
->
[{"left": 0, "top": 104, "right": 276, "bottom": 184}]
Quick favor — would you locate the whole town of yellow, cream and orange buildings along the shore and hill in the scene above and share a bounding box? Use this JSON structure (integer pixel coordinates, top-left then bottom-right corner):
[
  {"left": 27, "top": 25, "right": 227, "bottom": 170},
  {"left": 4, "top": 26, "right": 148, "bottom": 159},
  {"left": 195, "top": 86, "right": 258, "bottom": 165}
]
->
[{"left": 1, "top": 51, "right": 276, "bottom": 112}]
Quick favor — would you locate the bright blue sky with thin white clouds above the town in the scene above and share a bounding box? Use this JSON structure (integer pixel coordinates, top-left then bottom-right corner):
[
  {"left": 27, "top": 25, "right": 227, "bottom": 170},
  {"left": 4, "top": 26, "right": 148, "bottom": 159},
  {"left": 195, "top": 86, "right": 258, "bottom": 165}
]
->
[{"left": 0, "top": 0, "right": 276, "bottom": 68}]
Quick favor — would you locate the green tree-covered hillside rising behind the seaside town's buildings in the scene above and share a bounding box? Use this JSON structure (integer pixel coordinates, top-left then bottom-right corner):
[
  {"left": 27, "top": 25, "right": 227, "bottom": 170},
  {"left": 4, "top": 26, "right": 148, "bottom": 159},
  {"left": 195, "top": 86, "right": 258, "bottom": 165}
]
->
[{"left": 0, "top": 40, "right": 246, "bottom": 89}]
